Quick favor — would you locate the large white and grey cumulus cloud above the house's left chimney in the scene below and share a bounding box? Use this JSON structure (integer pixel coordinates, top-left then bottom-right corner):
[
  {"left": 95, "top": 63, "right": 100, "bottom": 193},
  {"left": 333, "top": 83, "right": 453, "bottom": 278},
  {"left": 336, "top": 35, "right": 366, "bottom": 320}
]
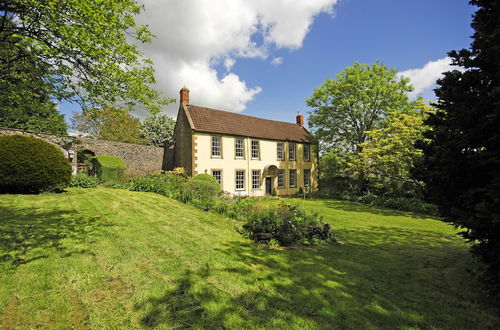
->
[{"left": 138, "top": 0, "right": 338, "bottom": 115}]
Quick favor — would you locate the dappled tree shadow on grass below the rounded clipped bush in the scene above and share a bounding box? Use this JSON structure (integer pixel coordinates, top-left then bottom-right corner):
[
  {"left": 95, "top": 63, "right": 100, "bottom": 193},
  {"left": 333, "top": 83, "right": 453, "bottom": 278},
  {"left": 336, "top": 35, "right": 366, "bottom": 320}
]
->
[{"left": 0, "top": 206, "right": 111, "bottom": 266}]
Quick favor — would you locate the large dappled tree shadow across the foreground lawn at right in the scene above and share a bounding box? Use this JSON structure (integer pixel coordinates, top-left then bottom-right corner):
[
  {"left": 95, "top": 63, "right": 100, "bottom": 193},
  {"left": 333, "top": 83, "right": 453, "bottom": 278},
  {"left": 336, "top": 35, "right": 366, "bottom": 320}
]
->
[{"left": 137, "top": 227, "right": 498, "bottom": 329}]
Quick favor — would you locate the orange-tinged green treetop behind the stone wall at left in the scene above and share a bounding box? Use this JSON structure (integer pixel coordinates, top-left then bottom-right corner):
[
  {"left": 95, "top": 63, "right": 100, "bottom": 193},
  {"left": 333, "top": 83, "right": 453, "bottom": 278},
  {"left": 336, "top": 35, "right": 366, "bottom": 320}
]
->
[{"left": 72, "top": 107, "right": 147, "bottom": 144}]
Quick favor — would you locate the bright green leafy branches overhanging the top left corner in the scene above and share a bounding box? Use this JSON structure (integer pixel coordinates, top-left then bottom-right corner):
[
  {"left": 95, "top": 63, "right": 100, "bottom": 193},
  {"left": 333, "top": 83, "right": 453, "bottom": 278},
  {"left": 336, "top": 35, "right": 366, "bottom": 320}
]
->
[{"left": 0, "top": 0, "right": 171, "bottom": 112}]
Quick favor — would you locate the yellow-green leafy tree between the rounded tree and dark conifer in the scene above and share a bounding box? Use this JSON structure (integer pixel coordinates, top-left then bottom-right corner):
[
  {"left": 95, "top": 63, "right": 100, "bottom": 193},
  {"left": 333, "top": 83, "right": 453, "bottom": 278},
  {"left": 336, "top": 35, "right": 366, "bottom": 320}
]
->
[{"left": 349, "top": 99, "right": 433, "bottom": 181}]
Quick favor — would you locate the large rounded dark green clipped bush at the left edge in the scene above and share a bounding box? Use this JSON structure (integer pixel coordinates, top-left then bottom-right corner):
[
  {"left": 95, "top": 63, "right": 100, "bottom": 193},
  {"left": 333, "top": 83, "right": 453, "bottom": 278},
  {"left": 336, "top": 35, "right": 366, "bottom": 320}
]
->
[{"left": 0, "top": 135, "right": 71, "bottom": 193}]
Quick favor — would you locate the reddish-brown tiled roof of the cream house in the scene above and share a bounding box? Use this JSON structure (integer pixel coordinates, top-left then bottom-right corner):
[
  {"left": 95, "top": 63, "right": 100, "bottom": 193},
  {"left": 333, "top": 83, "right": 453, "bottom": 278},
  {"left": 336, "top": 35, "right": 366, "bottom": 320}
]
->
[{"left": 186, "top": 105, "right": 311, "bottom": 142}]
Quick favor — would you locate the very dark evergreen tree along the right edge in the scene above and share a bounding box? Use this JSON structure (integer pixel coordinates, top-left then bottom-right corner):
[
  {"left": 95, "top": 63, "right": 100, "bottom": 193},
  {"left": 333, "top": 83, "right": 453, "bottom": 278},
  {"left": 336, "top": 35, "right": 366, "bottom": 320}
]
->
[{"left": 419, "top": 0, "right": 500, "bottom": 293}]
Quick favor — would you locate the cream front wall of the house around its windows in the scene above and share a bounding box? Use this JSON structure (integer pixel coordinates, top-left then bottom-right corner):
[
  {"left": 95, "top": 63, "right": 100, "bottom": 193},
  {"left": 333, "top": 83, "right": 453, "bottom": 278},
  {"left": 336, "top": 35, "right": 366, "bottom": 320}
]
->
[{"left": 193, "top": 132, "right": 318, "bottom": 196}]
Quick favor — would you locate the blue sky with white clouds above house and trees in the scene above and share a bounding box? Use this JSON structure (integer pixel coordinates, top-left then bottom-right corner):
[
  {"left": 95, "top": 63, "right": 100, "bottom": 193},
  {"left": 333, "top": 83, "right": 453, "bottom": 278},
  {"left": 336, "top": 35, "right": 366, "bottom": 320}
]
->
[{"left": 59, "top": 0, "right": 475, "bottom": 128}]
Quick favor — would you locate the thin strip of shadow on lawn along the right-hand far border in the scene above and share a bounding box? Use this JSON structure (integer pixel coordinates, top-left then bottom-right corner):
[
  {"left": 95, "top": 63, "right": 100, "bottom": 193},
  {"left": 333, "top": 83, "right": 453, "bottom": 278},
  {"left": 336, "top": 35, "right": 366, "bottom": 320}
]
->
[{"left": 322, "top": 199, "right": 437, "bottom": 219}]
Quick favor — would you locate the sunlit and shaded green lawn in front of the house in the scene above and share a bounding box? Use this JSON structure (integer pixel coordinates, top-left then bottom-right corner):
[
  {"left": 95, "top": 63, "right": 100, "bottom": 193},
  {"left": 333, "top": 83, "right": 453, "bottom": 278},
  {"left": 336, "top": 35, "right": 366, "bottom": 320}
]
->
[{"left": 0, "top": 188, "right": 500, "bottom": 329}]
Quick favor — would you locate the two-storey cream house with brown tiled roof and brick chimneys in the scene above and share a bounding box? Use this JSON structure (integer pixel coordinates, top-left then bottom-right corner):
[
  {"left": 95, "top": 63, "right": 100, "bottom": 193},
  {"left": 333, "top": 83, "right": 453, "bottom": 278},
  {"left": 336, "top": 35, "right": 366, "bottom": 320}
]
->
[{"left": 174, "top": 88, "right": 318, "bottom": 196}]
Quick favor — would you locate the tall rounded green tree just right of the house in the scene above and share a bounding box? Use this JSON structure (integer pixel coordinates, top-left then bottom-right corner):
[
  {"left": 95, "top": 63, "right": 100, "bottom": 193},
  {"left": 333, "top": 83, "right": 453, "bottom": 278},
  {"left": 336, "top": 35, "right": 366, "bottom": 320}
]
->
[{"left": 306, "top": 62, "right": 412, "bottom": 152}]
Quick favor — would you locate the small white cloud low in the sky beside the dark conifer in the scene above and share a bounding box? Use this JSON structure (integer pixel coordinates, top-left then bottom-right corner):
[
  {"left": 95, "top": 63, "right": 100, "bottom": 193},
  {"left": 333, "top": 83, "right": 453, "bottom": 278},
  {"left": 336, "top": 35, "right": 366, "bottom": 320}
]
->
[{"left": 398, "top": 57, "right": 457, "bottom": 98}]
